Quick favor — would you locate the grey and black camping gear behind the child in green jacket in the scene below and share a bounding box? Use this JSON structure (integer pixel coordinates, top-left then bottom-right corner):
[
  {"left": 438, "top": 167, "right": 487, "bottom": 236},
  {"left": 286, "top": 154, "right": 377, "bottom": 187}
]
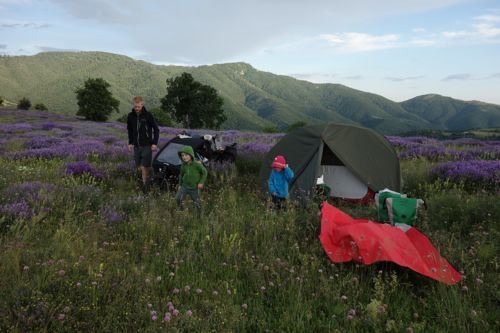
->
[{"left": 153, "top": 134, "right": 237, "bottom": 190}]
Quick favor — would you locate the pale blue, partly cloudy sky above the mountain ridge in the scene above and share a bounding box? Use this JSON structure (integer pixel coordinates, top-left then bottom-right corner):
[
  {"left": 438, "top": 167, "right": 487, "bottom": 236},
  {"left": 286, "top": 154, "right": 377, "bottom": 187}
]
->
[{"left": 0, "top": 0, "right": 500, "bottom": 105}]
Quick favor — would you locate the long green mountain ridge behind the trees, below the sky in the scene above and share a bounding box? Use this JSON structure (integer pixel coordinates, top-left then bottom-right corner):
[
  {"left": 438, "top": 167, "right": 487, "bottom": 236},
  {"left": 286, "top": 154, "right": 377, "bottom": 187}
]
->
[{"left": 0, "top": 52, "right": 500, "bottom": 134}]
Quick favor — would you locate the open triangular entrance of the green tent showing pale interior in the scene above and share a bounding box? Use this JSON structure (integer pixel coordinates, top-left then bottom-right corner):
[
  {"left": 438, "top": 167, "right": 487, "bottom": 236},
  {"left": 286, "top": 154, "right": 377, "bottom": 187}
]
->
[{"left": 320, "top": 144, "right": 368, "bottom": 199}]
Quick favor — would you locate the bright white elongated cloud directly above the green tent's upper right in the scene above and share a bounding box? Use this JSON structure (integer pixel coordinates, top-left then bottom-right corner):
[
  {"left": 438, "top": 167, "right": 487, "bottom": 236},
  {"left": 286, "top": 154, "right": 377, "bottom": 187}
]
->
[{"left": 320, "top": 32, "right": 400, "bottom": 52}]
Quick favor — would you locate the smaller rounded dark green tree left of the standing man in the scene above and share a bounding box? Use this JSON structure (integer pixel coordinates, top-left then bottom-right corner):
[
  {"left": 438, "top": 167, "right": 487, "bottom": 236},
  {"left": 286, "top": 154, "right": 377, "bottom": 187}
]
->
[{"left": 75, "top": 78, "right": 120, "bottom": 121}]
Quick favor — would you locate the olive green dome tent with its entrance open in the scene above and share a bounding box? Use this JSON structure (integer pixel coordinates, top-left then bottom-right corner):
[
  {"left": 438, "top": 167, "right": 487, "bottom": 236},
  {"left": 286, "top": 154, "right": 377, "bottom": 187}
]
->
[{"left": 258, "top": 124, "right": 401, "bottom": 201}]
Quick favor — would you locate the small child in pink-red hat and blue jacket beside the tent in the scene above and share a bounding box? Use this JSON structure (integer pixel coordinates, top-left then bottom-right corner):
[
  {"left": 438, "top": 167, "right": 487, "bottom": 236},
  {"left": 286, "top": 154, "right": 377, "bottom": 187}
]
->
[{"left": 268, "top": 155, "right": 294, "bottom": 209}]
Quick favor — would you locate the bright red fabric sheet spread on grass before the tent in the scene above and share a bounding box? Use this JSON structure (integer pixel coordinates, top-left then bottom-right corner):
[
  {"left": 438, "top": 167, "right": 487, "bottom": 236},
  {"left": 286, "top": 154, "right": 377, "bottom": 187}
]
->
[{"left": 319, "top": 202, "right": 462, "bottom": 284}]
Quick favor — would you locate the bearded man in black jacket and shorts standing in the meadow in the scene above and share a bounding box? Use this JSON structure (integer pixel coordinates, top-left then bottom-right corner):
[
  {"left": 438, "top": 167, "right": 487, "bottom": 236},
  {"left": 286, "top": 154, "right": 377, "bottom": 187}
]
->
[{"left": 127, "top": 96, "right": 160, "bottom": 192}]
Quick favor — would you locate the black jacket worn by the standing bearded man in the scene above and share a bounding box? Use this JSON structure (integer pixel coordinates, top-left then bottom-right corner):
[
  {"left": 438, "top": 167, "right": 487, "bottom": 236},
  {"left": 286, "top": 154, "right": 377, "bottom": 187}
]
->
[{"left": 127, "top": 107, "right": 160, "bottom": 147}]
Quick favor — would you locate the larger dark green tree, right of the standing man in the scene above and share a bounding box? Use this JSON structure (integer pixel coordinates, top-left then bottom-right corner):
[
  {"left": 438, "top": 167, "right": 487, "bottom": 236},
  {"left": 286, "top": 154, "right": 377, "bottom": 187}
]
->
[{"left": 161, "top": 72, "right": 227, "bottom": 129}]
